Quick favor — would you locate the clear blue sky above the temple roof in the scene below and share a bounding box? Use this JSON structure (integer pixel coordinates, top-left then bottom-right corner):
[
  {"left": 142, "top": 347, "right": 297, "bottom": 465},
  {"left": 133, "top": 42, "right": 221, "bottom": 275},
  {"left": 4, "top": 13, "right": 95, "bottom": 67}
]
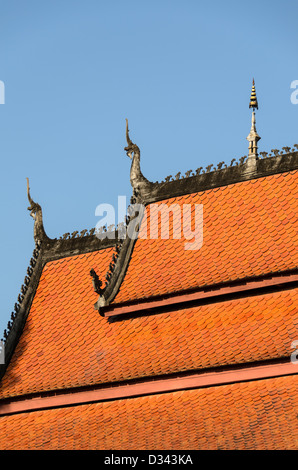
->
[{"left": 0, "top": 0, "right": 298, "bottom": 337}]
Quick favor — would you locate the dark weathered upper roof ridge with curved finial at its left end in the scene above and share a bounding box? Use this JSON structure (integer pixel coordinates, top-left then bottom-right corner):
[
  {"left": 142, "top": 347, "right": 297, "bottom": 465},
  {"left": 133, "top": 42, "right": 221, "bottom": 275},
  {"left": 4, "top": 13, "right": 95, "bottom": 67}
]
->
[{"left": 124, "top": 120, "right": 298, "bottom": 205}]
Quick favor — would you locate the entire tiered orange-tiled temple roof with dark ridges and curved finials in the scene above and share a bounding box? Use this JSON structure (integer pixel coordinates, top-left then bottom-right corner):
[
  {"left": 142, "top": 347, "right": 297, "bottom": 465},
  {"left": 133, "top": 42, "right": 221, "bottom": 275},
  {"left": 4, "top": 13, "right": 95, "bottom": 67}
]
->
[{"left": 0, "top": 116, "right": 298, "bottom": 449}]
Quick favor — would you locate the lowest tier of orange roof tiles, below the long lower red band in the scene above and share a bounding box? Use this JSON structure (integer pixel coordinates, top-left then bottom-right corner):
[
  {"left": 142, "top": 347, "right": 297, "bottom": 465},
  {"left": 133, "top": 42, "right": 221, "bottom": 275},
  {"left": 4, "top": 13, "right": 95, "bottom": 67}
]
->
[{"left": 0, "top": 375, "right": 298, "bottom": 450}]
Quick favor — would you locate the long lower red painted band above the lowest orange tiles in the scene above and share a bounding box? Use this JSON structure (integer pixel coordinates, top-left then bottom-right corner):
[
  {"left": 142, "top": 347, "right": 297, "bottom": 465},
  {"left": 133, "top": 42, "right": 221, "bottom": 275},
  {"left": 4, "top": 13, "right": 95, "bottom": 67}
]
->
[{"left": 0, "top": 362, "right": 298, "bottom": 416}]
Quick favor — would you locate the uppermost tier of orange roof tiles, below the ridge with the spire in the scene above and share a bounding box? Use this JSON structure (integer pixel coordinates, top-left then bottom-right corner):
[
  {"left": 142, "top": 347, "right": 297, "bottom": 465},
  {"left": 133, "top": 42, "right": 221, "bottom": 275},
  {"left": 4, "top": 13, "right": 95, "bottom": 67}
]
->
[{"left": 113, "top": 171, "right": 298, "bottom": 304}]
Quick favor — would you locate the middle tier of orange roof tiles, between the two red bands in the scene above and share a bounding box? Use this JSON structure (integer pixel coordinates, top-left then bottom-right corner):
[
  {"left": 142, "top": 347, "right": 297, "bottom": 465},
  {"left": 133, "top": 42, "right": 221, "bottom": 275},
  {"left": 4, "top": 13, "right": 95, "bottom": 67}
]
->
[{"left": 0, "top": 241, "right": 298, "bottom": 398}]
